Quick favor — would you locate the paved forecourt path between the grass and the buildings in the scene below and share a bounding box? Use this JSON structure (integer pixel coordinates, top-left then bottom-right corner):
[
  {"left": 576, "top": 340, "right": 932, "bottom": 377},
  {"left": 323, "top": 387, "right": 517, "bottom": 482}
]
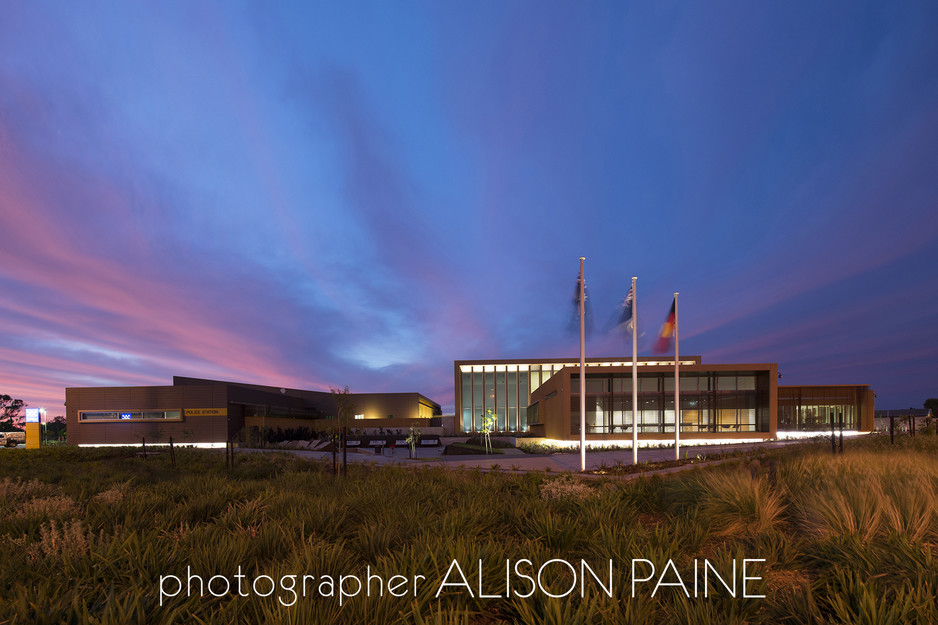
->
[{"left": 238, "top": 441, "right": 800, "bottom": 472}]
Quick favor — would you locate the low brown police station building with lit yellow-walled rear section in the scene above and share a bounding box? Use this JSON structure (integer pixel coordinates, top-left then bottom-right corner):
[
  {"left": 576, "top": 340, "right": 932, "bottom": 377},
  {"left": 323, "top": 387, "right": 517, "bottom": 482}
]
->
[{"left": 65, "top": 377, "right": 442, "bottom": 445}]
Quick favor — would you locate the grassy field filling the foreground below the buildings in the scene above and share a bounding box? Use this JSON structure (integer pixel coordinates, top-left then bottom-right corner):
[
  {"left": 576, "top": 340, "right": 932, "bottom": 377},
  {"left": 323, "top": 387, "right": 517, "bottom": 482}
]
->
[{"left": 0, "top": 436, "right": 938, "bottom": 625}]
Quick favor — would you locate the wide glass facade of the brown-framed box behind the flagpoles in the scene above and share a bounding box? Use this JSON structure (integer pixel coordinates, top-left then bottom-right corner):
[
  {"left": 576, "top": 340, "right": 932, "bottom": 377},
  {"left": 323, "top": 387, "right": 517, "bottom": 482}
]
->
[{"left": 570, "top": 371, "right": 771, "bottom": 435}]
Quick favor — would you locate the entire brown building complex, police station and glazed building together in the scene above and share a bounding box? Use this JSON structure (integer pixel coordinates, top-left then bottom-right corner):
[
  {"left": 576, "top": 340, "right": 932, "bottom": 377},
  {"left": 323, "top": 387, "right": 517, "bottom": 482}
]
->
[{"left": 65, "top": 356, "right": 874, "bottom": 445}]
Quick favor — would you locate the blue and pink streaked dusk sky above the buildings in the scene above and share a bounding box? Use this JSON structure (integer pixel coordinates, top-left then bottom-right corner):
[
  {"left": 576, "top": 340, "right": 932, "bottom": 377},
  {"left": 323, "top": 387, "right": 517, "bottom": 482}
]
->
[{"left": 0, "top": 0, "right": 938, "bottom": 417}]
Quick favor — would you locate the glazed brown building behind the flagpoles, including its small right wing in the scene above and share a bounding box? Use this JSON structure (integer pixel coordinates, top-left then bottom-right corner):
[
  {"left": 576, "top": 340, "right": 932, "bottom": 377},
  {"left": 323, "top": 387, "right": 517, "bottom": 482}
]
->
[{"left": 454, "top": 356, "right": 873, "bottom": 442}]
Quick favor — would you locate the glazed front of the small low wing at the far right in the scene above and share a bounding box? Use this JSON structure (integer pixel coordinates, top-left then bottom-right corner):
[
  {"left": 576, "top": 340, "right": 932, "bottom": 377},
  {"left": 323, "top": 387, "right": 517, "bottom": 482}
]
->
[{"left": 778, "top": 386, "right": 861, "bottom": 432}]
